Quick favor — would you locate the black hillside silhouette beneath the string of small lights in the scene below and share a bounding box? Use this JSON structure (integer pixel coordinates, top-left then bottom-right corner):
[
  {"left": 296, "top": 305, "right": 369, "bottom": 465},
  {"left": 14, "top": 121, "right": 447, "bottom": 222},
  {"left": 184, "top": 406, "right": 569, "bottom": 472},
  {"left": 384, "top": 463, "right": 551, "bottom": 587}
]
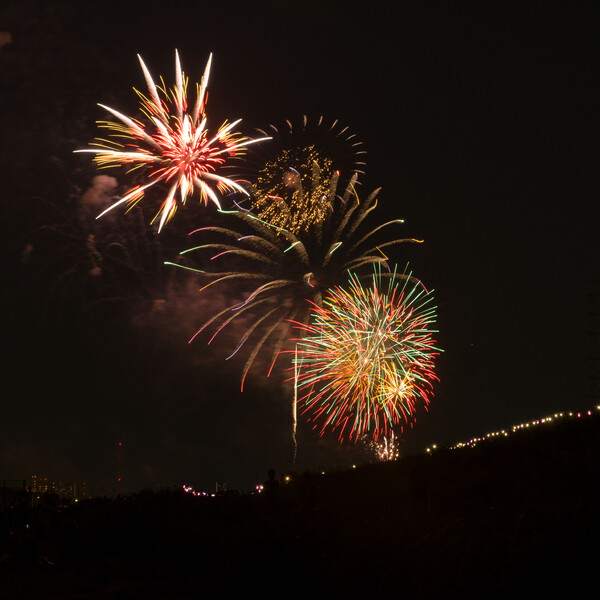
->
[{"left": 0, "top": 412, "right": 600, "bottom": 599}]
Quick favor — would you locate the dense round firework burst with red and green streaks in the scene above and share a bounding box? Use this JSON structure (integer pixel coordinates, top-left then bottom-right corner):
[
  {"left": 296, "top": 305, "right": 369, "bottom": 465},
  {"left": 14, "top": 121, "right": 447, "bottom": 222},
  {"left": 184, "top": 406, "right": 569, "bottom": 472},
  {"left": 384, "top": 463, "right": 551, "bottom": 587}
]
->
[{"left": 294, "top": 268, "right": 439, "bottom": 441}]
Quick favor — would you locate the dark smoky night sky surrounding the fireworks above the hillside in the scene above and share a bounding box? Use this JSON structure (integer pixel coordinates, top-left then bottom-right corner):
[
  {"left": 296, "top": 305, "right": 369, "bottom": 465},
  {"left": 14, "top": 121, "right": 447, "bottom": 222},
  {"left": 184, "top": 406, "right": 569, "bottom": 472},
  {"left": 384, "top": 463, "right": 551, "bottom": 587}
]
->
[{"left": 0, "top": 1, "right": 600, "bottom": 493}]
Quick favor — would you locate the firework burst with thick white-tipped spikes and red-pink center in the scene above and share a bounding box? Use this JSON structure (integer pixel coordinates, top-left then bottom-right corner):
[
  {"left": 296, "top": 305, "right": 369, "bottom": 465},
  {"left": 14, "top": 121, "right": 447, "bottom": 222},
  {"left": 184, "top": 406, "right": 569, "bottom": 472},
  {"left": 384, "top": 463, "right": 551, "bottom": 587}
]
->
[{"left": 78, "top": 51, "right": 265, "bottom": 231}]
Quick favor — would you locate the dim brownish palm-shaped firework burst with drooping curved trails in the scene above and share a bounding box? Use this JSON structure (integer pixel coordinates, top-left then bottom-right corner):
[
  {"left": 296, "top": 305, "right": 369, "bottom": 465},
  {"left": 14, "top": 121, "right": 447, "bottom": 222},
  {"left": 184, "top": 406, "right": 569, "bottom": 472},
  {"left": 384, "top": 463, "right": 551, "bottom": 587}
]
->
[{"left": 166, "top": 174, "right": 419, "bottom": 387}]
